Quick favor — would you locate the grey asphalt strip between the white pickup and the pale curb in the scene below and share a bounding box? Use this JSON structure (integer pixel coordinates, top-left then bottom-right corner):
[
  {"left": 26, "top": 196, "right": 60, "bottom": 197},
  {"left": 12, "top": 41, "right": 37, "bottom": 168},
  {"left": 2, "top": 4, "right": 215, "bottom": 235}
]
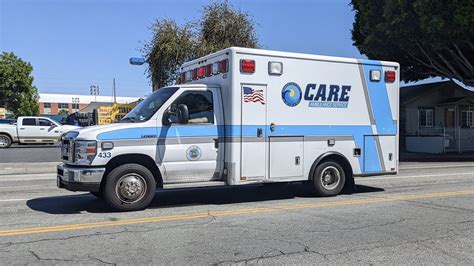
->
[{"left": 0, "top": 144, "right": 61, "bottom": 163}]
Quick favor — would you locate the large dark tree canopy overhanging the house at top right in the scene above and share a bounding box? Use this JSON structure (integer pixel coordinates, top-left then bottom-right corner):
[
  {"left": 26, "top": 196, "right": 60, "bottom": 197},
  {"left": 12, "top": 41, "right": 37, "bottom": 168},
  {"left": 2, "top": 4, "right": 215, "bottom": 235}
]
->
[{"left": 352, "top": 0, "right": 474, "bottom": 86}]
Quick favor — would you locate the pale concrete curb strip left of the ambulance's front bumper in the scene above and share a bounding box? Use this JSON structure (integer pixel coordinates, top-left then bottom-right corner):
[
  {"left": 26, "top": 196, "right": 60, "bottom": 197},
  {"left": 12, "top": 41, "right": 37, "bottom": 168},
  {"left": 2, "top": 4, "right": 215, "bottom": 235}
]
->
[{"left": 0, "top": 162, "right": 60, "bottom": 176}]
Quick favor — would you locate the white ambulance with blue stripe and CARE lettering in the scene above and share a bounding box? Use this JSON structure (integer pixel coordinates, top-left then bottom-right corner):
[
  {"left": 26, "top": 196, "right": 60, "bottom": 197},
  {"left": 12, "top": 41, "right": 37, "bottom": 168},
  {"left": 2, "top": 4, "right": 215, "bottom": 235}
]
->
[{"left": 57, "top": 48, "right": 399, "bottom": 210}]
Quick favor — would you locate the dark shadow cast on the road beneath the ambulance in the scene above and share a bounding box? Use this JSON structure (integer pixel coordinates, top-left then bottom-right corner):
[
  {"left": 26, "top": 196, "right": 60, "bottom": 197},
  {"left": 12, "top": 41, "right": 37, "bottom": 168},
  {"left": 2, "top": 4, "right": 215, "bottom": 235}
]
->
[{"left": 26, "top": 183, "right": 384, "bottom": 214}]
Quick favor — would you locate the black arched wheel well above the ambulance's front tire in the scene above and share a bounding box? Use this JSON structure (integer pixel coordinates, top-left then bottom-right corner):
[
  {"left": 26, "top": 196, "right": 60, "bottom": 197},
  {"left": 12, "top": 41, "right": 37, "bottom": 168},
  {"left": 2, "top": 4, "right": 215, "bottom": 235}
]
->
[{"left": 101, "top": 154, "right": 163, "bottom": 188}]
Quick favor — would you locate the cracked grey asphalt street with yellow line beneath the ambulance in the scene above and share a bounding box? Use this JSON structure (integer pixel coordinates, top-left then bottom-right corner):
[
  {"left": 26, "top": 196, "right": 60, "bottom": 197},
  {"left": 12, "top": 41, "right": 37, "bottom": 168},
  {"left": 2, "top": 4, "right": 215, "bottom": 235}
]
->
[{"left": 0, "top": 163, "right": 474, "bottom": 265}]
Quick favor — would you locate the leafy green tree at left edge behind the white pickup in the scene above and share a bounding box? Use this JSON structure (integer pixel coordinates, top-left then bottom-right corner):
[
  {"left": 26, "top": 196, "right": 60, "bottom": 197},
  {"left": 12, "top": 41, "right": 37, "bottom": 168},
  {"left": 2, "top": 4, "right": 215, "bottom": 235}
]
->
[{"left": 0, "top": 52, "right": 39, "bottom": 116}]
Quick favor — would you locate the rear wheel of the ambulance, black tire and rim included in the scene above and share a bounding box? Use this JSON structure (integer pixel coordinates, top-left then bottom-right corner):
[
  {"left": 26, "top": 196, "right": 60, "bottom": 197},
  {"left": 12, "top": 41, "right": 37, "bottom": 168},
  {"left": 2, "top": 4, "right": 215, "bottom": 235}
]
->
[{"left": 312, "top": 161, "right": 346, "bottom": 197}]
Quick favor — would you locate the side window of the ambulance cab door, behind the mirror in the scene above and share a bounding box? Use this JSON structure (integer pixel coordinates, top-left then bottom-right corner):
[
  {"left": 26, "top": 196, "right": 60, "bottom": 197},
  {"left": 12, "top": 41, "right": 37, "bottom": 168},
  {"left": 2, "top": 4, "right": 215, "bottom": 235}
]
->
[{"left": 170, "top": 91, "right": 214, "bottom": 125}]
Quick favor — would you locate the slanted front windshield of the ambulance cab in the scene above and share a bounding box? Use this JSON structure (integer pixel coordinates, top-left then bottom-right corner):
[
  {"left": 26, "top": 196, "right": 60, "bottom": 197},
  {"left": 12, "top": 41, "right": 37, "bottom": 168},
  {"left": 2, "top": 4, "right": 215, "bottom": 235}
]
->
[{"left": 122, "top": 87, "right": 178, "bottom": 122}]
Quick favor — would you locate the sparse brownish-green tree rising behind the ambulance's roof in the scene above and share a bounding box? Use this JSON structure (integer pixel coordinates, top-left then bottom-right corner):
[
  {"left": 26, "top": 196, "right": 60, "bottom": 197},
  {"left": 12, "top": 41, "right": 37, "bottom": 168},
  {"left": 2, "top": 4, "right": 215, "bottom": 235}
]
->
[{"left": 143, "top": 2, "right": 258, "bottom": 89}]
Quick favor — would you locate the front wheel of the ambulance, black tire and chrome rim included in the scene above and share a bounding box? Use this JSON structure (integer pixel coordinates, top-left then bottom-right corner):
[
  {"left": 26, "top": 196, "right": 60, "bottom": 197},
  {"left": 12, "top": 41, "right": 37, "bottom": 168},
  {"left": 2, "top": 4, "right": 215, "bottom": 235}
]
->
[{"left": 103, "top": 163, "right": 156, "bottom": 211}]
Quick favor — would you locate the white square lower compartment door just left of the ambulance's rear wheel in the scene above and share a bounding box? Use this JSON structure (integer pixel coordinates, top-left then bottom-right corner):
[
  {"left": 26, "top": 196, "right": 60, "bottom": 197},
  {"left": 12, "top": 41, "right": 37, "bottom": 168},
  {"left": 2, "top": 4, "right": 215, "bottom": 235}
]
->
[{"left": 269, "top": 136, "right": 304, "bottom": 180}]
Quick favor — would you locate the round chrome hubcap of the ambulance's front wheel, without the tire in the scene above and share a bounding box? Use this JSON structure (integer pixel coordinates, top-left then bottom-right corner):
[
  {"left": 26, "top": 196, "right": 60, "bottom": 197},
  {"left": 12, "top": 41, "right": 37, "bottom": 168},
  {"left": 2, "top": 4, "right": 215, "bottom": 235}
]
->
[{"left": 115, "top": 173, "right": 147, "bottom": 203}]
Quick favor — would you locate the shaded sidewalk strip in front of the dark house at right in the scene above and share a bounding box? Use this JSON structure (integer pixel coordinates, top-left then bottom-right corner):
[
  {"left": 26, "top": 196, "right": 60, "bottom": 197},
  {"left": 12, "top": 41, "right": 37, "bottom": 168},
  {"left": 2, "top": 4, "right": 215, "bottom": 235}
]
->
[{"left": 400, "top": 151, "right": 474, "bottom": 162}]
